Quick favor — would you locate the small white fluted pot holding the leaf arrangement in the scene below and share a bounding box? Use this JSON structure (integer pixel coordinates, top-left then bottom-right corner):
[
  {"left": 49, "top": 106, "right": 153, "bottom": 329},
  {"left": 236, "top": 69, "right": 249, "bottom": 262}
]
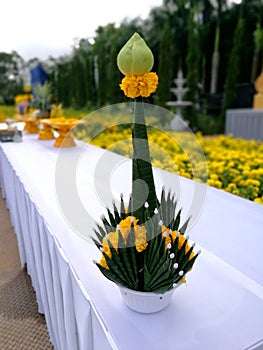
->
[{"left": 118, "top": 285, "right": 176, "bottom": 314}]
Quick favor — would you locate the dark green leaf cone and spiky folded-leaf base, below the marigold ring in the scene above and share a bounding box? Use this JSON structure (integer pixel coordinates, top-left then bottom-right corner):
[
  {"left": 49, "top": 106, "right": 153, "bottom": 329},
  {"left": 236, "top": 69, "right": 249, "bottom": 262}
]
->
[{"left": 93, "top": 100, "right": 199, "bottom": 293}]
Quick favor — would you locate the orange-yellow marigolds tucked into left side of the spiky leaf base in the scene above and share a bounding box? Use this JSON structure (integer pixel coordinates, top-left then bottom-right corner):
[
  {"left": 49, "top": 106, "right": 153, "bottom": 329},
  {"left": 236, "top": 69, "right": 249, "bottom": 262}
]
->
[{"left": 100, "top": 216, "right": 148, "bottom": 268}]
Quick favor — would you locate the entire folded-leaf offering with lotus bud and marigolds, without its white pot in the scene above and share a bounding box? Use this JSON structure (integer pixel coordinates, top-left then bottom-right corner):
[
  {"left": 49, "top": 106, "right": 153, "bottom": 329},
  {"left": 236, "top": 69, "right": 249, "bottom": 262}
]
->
[{"left": 93, "top": 33, "right": 199, "bottom": 293}]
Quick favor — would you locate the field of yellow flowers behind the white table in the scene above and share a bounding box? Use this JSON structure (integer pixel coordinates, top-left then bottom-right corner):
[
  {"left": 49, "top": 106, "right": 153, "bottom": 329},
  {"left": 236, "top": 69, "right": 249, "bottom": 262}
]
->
[{"left": 73, "top": 113, "right": 263, "bottom": 204}]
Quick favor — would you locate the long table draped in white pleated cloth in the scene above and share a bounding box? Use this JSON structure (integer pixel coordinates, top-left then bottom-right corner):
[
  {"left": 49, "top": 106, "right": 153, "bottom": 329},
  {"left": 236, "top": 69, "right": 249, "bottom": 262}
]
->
[{"left": 0, "top": 135, "right": 263, "bottom": 350}]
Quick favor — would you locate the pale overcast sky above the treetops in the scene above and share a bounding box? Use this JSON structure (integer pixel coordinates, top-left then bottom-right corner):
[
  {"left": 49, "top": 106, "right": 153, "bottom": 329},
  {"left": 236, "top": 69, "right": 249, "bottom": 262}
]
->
[{"left": 0, "top": 0, "right": 163, "bottom": 60}]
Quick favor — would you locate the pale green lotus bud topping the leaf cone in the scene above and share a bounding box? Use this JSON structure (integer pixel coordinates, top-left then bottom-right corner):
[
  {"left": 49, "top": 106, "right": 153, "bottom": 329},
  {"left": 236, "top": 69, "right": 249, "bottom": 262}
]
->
[{"left": 117, "top": 33, "right": 154, "bottom": 75}]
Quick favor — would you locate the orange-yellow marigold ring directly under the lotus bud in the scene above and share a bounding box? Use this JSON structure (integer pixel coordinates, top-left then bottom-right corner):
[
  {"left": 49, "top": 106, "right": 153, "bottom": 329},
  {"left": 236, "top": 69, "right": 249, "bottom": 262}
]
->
[{"left": 120, "top": 72, "right": 158, "bottom": 98}]
